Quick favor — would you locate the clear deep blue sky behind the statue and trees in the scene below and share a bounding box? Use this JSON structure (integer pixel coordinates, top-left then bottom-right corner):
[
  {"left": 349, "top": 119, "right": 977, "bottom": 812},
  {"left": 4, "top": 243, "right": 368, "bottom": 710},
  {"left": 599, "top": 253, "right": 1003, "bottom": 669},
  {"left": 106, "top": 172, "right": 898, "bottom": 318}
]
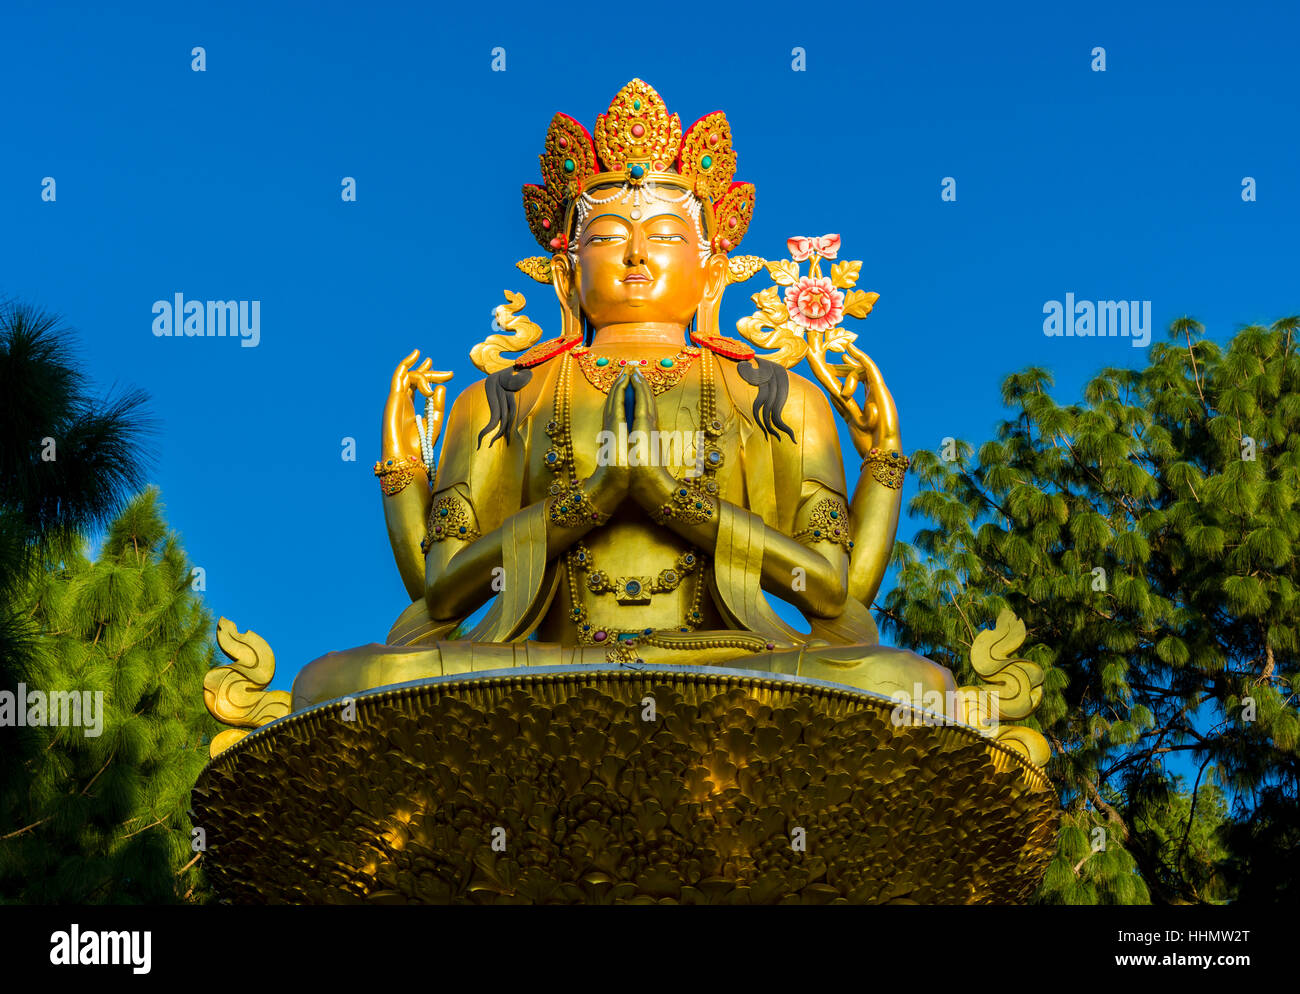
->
[{"left": 0, "top": 0, "right": 1300, "bottom": 689}]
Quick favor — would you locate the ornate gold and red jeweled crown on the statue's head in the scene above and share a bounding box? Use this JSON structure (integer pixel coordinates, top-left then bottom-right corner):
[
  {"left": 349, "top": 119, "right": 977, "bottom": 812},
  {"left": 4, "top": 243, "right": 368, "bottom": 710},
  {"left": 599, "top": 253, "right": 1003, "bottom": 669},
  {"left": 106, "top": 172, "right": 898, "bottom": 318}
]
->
[{"left": 524, "top": 79, "right": 754, "bottom": 252}]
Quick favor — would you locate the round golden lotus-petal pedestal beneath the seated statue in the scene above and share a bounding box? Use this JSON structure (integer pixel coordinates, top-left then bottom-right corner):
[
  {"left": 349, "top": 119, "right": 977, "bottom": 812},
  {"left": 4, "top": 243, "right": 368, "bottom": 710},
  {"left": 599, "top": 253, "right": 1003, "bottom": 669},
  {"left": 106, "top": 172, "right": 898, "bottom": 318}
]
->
[{"left": 192, "top": 667, "right": 1058, "bottom": 904}]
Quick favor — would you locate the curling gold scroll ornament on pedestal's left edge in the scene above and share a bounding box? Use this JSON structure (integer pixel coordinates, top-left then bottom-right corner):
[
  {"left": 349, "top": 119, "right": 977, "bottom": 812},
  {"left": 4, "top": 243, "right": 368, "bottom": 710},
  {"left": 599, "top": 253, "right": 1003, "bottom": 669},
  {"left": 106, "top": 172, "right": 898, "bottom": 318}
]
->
[{"left": 203, "top": 618, "right": 293, "bottom": 759}]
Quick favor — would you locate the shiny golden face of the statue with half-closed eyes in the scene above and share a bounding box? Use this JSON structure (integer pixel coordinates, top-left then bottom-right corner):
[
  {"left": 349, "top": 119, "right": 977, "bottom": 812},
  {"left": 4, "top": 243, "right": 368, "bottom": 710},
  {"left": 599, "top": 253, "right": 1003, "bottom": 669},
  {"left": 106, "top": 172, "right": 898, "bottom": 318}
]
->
[{"left": 577, "top": 184, "right": 709, "bottom": 329}]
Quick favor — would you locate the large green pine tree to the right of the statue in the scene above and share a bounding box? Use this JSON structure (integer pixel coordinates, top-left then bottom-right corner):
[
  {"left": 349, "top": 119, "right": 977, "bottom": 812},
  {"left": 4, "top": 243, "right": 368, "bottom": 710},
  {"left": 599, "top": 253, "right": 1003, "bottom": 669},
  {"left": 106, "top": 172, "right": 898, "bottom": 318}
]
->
[{"left": 883, "top": 317, "right": 1300, "bottom": 903}]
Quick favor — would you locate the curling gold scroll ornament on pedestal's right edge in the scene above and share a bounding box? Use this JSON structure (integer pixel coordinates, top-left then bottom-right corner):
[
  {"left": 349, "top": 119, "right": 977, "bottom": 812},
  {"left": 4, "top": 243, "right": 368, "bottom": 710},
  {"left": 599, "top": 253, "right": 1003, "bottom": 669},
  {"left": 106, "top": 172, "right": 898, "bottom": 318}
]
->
[{"left": 957, "top": 611, "right": 1052, "bottom": 767}]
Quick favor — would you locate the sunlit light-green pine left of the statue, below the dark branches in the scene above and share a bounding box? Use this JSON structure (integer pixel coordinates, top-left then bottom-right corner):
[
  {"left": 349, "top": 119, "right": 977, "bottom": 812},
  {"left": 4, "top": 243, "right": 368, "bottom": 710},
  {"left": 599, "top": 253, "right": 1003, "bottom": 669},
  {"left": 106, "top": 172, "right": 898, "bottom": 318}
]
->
[{"left": 0, "top": 489, "right": 216, "bottom": 903}]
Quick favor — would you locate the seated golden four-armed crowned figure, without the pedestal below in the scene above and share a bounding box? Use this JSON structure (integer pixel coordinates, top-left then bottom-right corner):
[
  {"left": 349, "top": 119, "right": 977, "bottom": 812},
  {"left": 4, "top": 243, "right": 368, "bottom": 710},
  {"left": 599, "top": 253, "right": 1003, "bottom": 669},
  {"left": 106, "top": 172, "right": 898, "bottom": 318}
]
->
[{"left": 293, "top": 79, "right": 962, "bottom": 720}]
